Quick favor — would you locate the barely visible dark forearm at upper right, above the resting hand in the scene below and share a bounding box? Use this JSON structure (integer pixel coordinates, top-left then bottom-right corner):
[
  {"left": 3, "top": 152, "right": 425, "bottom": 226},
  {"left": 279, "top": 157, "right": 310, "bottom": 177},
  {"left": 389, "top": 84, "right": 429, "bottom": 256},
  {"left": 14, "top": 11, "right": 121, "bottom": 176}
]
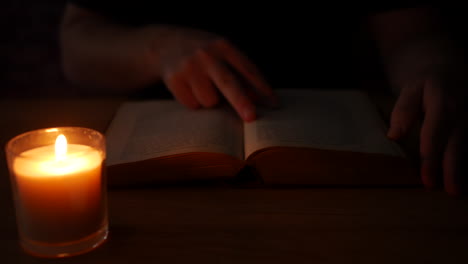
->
[{"left": 370, "top": 7, "right": 459, "bottom": 89}]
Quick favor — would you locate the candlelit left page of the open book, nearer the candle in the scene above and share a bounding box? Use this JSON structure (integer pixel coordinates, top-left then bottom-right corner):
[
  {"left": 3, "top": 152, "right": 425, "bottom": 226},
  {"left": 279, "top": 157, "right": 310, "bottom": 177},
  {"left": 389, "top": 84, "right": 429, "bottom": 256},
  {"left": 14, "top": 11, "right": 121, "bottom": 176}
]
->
[{"left": 106, "top": 100, "right": 244, "bottom": 165}]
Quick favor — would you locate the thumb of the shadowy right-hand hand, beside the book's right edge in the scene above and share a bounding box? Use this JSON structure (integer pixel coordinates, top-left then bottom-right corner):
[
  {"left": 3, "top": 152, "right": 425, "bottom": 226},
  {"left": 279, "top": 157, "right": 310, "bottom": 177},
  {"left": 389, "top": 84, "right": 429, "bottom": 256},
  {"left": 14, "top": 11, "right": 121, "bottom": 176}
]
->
[{"left": 387, "top": 83, "right": 423, "bottom": 140}]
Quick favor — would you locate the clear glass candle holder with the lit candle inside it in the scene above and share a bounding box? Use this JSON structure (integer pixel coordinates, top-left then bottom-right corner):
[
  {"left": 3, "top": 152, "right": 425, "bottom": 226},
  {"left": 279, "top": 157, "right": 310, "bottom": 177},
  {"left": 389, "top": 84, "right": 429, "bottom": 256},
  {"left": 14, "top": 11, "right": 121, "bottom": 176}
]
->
[{"left": 5, "top": 127, "right": 108, "bottom": 258}]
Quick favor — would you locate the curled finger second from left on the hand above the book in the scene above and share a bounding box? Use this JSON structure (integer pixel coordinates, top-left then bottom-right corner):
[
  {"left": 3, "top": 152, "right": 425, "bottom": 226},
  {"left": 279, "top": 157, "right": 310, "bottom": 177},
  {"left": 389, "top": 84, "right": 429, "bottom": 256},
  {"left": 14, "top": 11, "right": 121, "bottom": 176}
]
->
[{"left": 187, "top": 61, "right": 219, "bottom": 108}]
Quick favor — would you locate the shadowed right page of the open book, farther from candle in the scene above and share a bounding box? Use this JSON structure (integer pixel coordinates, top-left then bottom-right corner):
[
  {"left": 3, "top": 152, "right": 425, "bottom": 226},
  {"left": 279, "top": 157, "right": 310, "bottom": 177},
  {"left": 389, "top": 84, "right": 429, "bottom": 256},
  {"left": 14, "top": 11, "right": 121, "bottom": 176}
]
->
[{"left": 244, "top": 89, "right": 402, "bottom": 157}]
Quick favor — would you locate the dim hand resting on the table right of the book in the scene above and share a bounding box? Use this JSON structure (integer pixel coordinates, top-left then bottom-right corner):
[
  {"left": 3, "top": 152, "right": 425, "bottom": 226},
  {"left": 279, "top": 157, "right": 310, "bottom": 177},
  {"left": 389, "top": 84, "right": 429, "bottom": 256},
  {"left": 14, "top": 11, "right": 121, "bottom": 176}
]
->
[{"left": 388, "top": 40, "right": 468, "bottom": 195}]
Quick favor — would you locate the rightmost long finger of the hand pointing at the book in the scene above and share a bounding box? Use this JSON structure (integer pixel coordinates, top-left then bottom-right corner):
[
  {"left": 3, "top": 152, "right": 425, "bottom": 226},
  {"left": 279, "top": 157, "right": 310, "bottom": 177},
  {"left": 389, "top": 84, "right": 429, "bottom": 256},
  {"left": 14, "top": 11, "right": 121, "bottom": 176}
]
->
[{"left": 214, "top": 39, "right": 278, "bottom": 107}]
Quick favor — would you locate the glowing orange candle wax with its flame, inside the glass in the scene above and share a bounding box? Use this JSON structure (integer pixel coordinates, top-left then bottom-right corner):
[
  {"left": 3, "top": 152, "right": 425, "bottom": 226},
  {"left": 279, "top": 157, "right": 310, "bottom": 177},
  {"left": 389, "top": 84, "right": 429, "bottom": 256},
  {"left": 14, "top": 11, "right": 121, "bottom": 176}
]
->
[{"left": 5, "top": 128, "right": 107, "bottom": 256}]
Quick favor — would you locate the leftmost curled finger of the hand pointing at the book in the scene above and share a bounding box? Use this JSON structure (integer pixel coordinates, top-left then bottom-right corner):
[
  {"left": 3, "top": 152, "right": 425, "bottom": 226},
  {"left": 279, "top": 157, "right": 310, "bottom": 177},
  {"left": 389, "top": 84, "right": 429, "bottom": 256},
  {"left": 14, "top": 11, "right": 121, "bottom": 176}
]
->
[{"left": 164, "top": 72, "right": 200, "bottom": 109}]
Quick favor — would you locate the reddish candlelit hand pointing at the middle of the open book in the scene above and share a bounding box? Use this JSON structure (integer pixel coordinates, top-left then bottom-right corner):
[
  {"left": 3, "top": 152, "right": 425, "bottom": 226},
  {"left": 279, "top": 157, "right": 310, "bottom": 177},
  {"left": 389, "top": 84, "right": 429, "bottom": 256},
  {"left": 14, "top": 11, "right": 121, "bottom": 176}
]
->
[{"left": 148, "top": 28, "right": 277, "bottom": 121}]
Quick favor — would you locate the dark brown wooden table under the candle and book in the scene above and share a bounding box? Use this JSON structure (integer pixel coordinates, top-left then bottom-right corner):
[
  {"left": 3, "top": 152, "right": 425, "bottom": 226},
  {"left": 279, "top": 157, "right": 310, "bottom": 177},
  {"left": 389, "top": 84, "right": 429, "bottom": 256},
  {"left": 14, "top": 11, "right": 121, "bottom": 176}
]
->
[{"left": 0, "top": 99, "right": 468, "bottom": 264}]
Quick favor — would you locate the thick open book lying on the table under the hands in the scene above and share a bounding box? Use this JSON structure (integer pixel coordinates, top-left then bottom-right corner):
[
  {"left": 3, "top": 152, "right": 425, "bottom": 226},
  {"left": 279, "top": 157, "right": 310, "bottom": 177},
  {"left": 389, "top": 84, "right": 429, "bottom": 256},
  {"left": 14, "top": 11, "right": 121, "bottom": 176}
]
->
[{"left": 106, "top": 89, "right": 419, "bottom": 185}]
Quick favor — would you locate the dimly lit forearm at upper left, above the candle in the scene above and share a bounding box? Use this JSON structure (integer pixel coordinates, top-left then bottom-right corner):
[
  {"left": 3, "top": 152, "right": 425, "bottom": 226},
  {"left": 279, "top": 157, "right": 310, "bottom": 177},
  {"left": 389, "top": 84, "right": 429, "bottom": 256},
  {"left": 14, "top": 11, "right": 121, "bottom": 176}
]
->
[{"left": 61, "top": 5, "right": 159, "bottom": 93}]
